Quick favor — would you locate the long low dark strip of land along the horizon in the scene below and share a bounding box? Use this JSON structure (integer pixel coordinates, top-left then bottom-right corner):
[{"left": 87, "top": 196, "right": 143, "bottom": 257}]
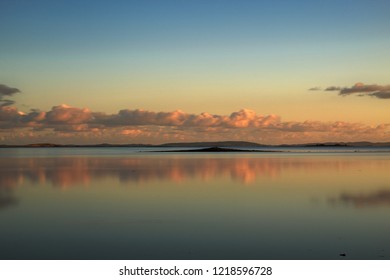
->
[{"left": 0, "top": 141, "right": 390, "bottom": 148}]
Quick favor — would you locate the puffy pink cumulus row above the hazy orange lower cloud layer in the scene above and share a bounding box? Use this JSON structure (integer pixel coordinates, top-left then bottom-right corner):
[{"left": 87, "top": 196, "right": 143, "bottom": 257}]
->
[{"left": 0, "top": 104, "right": 280, "bottom": 131}]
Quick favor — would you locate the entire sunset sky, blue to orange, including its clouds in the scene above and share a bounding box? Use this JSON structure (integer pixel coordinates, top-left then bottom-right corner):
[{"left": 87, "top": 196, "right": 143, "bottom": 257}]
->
[{"left": 0, "top": 0, "right": 390, "bottom": 144}]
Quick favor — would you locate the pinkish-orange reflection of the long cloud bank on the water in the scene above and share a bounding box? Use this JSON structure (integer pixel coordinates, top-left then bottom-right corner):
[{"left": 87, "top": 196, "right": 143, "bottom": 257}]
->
[{"left": 0, "top": 157, "right": 390, "bottom": 188}]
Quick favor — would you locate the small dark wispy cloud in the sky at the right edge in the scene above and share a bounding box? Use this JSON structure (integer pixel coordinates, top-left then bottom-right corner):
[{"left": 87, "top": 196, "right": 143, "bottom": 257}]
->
[{"left": 325, "top": 83, "right": 390, "bottom": 99}]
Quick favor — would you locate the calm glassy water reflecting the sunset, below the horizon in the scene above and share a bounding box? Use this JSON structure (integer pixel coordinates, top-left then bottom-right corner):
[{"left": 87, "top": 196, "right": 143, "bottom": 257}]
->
[{"left": 0, "top": 148, "right": 390, "bottom": 259}]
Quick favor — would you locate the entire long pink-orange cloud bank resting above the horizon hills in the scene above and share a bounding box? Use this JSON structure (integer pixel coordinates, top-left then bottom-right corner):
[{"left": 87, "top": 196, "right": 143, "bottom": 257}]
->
[{"left": 0, "top": 104, "right": 390, "bottom": 144}]
